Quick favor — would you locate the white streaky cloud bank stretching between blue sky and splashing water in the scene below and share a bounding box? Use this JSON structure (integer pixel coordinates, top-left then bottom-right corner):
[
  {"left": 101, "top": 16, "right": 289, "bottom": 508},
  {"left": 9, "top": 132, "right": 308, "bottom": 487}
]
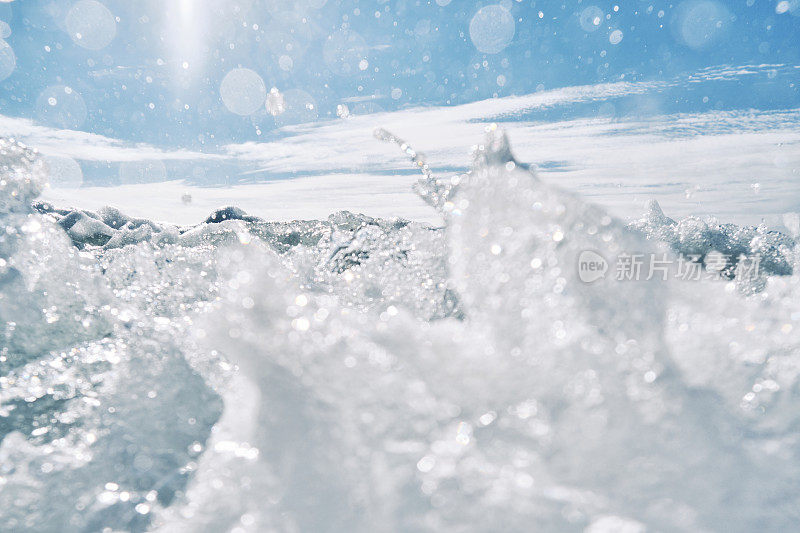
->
[{"left": 17, "top": 65, "right": 800, "bottom": 227}]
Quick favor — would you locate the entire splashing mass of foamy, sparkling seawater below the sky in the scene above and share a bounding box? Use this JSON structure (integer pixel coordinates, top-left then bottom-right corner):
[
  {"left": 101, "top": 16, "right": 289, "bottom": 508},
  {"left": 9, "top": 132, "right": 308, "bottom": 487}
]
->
[{"left": 0, "top": 130, "right": 800, "bottom": 532}]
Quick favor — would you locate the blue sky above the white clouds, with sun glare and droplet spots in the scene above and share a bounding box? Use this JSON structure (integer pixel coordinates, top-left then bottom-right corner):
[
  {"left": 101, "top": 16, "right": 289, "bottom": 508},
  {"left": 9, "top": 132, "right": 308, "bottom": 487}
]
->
[{"left": 0, "top": 0, "right": 800, "bottom": 152}]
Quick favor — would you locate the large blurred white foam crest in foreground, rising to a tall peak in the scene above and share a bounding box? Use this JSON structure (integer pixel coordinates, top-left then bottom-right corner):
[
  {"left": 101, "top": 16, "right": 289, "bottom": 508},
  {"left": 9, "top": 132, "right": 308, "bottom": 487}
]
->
[{"left": 159, "top": 131, "right": 798, "bottom": 531}]
